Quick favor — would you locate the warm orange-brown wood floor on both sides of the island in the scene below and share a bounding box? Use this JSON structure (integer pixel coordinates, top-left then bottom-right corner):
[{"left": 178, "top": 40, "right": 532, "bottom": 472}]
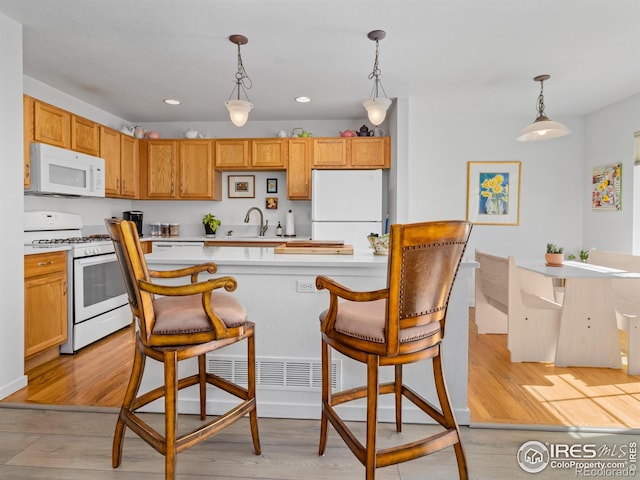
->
[{"left": 2, "top": 309, "right": 640, "bottom": 429}]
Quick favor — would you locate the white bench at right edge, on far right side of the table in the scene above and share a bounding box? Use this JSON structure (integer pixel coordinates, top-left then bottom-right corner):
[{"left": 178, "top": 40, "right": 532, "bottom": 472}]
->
[{"left": 589, "top": 250, "right": 640, "bottom": 375}]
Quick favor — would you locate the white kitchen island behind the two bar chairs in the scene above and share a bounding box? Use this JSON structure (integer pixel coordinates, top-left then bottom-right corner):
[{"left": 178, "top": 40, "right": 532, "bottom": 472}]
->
[{"left": 142, "top": 246, "right": 476, "bottom": 424}]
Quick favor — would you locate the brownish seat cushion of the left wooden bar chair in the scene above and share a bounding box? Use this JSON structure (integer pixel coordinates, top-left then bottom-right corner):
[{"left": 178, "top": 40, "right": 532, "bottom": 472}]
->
[{"left": 153, "top": 292, "right": 247, "bottom": 335}]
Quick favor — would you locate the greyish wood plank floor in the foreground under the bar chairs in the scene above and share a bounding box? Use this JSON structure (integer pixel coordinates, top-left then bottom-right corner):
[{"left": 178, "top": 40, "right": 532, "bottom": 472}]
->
[{"left": 0, "top": 404, "right": 637, "bottom": 480}]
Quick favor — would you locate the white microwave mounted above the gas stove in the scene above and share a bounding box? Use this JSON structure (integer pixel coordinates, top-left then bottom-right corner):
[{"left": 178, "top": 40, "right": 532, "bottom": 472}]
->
[{"left": 25, "top": 143, "right": 105, "bottom": 197}]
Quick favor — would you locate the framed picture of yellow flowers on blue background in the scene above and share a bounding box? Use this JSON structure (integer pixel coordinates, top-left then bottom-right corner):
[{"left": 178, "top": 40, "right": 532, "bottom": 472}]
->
[{"left": 467, "top": 162, "right": 520, "bottom": 225}]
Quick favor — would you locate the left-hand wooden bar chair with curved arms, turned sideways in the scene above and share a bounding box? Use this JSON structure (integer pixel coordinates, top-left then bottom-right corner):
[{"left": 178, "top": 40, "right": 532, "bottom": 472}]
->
[{"left": 105, "top": 219, "right": 260, "bottom": 480}]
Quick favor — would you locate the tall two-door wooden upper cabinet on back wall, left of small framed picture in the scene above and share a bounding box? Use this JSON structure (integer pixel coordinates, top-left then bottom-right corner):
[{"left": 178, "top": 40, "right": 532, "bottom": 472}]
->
[{"left": 140, "top": 140, "right": 222, "bottom": 200}]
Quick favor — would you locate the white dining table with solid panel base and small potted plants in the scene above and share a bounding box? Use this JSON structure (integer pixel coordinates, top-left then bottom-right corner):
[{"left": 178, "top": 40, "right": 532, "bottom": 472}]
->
[{"left": 516, "top": 260, "right": 640, "bottom": 368}]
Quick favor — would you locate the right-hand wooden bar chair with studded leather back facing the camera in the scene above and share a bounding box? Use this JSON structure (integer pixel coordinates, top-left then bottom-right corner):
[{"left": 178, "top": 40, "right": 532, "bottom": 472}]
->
[{"left": 316, "top": 221, "right": 472, "bottom": 480}]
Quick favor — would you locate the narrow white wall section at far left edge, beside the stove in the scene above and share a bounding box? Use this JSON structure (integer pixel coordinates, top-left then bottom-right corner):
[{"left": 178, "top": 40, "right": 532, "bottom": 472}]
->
[{"left": 0, "top": 14, "right": 27, "bottom": 398}]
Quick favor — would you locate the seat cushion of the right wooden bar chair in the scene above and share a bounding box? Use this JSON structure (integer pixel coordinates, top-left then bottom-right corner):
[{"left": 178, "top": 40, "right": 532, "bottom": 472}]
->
[{"left": 320, "top": 299, "right": 440, "bottom": 343}]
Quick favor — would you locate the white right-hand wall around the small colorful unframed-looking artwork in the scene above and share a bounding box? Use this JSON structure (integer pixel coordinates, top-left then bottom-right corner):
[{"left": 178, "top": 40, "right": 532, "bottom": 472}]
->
[{"left": 582, "top": 93, "right": 640, "bottom": 254}]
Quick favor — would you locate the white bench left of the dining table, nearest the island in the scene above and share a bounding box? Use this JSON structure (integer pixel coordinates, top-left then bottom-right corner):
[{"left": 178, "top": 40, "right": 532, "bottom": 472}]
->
[{"left": 475, "top": 250, "right": 562, "bottom": 362}]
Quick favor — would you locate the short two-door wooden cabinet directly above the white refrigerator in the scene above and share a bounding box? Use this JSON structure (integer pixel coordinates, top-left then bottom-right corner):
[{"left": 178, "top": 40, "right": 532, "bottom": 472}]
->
[{"left": 313, "top": 137, "right": 391, "bottom": 169}]
